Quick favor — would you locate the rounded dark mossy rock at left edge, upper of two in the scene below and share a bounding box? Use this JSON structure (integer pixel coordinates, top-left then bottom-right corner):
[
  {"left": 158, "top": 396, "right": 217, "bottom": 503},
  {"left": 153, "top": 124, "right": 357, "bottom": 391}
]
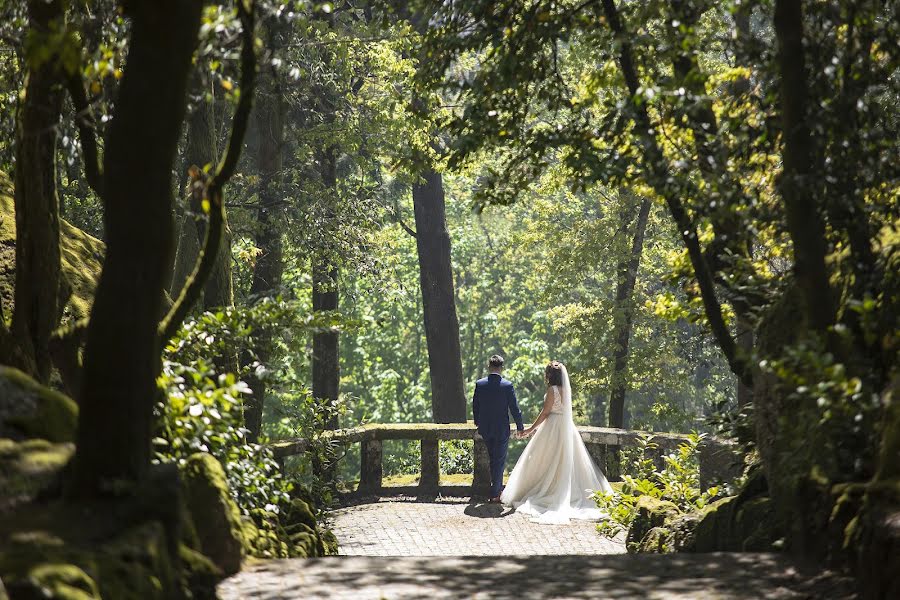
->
[{"left": 0, "top": 365, "right": 78, "bottom": 442}]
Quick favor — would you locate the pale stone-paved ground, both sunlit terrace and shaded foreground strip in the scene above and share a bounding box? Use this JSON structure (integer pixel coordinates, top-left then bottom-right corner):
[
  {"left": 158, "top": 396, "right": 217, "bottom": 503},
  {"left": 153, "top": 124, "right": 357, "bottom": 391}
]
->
[{"left": 219, "top": 498, "right": 855, "bottom": 600}]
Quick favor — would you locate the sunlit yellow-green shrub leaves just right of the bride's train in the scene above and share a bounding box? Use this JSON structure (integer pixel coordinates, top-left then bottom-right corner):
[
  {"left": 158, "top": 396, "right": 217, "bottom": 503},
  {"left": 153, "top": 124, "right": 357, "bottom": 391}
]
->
[{"left": 593, "top": 433, "right": 723, "bottom": 535}]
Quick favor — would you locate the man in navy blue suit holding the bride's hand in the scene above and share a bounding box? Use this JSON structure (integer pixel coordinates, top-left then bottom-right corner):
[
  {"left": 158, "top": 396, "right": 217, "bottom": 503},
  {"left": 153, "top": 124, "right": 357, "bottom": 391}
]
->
[{"left": 472, "top": 354, "right": 525, "bottom": 502}]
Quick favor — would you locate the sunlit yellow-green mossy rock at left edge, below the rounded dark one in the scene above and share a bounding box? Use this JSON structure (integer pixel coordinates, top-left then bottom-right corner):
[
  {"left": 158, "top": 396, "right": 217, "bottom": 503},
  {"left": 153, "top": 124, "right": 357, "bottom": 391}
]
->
[{"left": 0, "top": 438, "right": 75, "bottom": 512}]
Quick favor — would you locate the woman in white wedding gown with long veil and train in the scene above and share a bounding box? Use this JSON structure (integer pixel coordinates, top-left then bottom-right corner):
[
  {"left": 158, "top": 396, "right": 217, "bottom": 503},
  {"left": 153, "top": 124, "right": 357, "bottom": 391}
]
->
[{"left": 500, "top": 361, "right": 612, "bottom": 524}]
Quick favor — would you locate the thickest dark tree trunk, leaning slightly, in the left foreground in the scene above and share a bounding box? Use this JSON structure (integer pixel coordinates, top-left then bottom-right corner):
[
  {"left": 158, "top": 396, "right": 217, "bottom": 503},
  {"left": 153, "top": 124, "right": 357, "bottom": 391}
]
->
[{"left": 70, "top": 0, "right": 203, "bottom": 497}]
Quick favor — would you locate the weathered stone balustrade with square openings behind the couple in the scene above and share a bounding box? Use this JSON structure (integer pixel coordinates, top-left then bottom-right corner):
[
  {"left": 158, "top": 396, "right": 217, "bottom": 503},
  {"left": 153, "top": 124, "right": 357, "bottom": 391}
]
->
[{"left": 269, "top": 421, "right": 740, "bottom": 495}]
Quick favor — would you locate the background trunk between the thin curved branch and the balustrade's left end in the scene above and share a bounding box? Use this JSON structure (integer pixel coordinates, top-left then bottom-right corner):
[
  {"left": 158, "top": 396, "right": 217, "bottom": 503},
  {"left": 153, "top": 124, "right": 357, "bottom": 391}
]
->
[{"left": 244, "top": 69, "right": 284, "bottom": 441}]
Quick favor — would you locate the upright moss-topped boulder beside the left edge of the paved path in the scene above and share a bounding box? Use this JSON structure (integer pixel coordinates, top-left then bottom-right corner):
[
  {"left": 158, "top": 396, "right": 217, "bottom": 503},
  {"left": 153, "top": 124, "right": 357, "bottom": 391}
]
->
[{"left": 181, "top": 452, "right": 247, "bottom": 575}]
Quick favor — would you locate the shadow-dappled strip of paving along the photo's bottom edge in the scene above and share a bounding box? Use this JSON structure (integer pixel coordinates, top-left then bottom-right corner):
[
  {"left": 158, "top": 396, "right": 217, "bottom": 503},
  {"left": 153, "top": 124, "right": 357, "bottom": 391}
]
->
[{"left": 219, "top": 553, "right": 856, "bottom": 600}]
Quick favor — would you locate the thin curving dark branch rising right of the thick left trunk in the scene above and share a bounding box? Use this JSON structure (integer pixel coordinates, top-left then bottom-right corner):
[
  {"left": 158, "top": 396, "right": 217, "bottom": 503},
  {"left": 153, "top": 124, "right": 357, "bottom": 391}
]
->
[{"left": 159, "top": 0, "right": 256, "bottom": 343}]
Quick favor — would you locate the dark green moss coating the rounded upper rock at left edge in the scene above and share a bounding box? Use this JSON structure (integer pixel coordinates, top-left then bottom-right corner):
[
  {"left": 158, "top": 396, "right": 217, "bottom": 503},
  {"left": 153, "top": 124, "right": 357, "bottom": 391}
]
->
[{"left": 0, "top": 365, "right": 78, "bottom": 442}]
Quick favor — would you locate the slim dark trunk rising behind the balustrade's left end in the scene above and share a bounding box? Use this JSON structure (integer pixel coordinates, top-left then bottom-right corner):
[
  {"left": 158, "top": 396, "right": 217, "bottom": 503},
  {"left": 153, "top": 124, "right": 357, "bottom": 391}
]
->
[{"left": 312, "top": 148, "right": 341, "bottom": 429}]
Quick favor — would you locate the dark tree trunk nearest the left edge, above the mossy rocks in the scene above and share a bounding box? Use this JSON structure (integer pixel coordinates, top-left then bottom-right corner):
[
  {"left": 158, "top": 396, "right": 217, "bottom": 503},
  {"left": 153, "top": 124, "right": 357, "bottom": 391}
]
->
[{"left": 11, "top": 0, "right": 64, "bottom": 382}]
